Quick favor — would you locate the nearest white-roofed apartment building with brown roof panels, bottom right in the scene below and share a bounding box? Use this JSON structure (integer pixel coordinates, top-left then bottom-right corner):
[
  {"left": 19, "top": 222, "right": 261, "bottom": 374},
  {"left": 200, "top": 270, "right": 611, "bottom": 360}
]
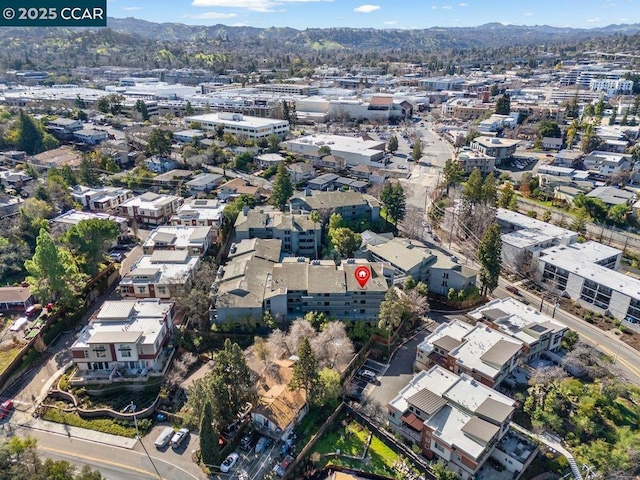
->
[{"left": 387, "top": 366, "right": 537, "bottom": 480}]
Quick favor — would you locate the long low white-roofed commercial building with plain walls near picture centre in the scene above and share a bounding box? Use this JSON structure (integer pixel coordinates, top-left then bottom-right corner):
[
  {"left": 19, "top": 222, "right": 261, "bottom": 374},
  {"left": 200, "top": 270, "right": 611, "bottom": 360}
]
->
[{"left": 282, "top": 134, "right": 385, "bottom": 166}]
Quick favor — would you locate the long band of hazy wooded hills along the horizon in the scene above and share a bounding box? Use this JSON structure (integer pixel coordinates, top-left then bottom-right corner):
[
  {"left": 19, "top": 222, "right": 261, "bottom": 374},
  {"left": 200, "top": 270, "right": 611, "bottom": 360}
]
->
[{"left": 107, "top": 17, "right": 640, "bottom": 50}]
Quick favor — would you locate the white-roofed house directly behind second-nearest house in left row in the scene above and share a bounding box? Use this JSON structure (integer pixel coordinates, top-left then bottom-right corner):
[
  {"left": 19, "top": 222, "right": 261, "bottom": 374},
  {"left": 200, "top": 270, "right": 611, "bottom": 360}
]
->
[{"left": 142, "top": 225, "right": 211, "bottom": 257}]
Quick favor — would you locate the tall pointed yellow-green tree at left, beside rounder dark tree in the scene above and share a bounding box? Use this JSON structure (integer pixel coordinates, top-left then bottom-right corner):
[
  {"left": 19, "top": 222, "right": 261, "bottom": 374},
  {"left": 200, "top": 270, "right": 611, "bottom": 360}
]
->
[{"left": 24, "top": 228, "right": 80, "bottom": 303}]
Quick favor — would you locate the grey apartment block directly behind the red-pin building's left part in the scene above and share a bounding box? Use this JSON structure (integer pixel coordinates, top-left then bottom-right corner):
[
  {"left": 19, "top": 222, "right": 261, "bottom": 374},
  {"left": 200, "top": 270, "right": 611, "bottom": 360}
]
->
[{"left": 234, "top": 207, "right": 322, "bottom": 258}]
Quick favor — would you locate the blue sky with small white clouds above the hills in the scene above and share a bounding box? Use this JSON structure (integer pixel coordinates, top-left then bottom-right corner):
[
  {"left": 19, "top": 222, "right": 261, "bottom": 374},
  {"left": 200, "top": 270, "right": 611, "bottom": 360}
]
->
[{"left": 107, "top": 0, "right": 640, "bottom": 29}]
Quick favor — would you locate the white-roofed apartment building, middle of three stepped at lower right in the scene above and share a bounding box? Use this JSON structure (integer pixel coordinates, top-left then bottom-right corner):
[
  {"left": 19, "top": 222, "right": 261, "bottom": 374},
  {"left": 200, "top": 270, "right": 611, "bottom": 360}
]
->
[{"left": 414, "top": 320, "right": 524, "bottom": 387}]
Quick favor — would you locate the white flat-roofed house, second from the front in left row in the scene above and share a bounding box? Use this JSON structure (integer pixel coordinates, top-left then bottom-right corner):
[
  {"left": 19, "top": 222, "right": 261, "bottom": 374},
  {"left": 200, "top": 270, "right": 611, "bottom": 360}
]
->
[{"left": 119, "top": 250, "right": 200, "bottom": 299}]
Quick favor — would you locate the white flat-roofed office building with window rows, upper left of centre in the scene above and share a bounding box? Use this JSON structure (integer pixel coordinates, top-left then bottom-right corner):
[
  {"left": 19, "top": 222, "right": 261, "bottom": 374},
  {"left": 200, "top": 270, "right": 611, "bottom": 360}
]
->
[{"left": 185, "top": 112, "right": 289, "bottom": 139}]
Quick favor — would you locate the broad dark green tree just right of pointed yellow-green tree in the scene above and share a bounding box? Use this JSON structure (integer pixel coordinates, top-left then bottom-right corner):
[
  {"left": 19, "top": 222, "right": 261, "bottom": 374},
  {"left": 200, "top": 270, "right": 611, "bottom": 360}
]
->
[{"left": 61, "top": 218, "right": 120, "bottom": 275}]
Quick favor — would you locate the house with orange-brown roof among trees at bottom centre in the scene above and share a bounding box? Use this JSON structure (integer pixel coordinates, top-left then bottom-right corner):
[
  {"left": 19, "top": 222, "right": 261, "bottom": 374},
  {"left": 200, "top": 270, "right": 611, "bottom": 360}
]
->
[{"left": 251, "top": 359, "right": 308, "bottom": 441}]
